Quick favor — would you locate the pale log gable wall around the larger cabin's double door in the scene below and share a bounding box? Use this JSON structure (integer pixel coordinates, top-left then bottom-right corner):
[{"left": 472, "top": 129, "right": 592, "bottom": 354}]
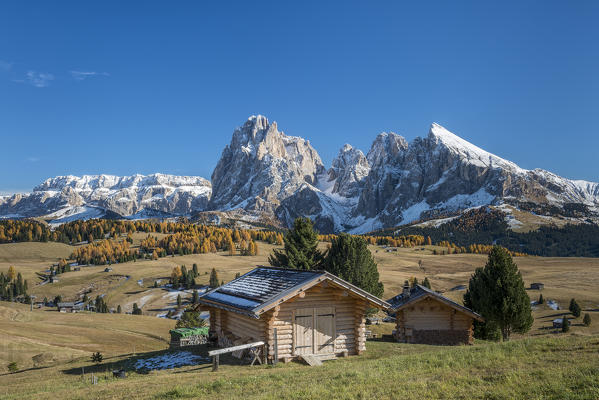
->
[{"left": 270, "top": 281, "right": 367, "bottom": 359}]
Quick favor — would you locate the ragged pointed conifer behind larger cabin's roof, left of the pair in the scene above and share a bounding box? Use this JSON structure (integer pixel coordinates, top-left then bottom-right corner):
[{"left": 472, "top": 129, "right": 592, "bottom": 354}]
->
[{"left": 268, "top": 217, "right": 324, "bottom": 270}]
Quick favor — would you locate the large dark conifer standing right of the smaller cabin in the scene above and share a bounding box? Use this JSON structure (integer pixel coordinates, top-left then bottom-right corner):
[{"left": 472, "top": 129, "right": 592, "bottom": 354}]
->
[{"left": 464, "top": 246, "right": 533, "bottom": 340}]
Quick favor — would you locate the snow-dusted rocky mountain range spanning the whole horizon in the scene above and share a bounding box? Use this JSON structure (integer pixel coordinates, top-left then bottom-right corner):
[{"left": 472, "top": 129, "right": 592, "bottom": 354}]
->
[{"left": 0, "top": 116, "right": 599, "bottom": 233}]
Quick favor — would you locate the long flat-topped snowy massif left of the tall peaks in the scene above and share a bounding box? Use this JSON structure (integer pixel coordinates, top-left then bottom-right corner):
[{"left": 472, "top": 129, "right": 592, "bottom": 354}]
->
[{"left": 0, "top": 174, "right": 211, "bottom": 222}]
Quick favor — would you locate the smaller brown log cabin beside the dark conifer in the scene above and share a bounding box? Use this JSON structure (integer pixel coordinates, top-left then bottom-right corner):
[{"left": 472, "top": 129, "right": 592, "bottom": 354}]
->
[{"left": 388, "top": 285, "right": 483, "bottom": 345}]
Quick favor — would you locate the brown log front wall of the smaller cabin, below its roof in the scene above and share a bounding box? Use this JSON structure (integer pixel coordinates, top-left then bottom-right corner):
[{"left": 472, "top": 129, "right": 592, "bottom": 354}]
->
[{"left": 395, "top": 297, "right": 473, "bottom": 345}]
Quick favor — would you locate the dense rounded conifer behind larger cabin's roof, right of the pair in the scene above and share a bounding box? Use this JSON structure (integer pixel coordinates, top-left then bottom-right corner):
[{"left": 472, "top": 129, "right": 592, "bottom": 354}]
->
[{"left": 323, "top": 233, "right": 383, "bottom": 297}]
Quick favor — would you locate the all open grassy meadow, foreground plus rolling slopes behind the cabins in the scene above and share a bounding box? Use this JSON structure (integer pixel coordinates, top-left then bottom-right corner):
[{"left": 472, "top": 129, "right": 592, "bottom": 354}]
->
[{"left": 0, "top": 238, "right": 599, "bottom": 399}]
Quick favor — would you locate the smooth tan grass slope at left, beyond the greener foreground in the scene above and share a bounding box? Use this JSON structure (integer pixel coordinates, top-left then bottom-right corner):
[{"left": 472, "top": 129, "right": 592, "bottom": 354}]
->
[{"left": 0, "top": 302, "right": 175, "bottom": 372}]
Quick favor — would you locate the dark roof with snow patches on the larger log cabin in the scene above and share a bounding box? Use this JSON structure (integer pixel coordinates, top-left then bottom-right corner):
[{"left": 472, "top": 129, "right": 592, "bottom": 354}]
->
[{"left": 199, "top": 266, "right": 390, "bottom": 318}]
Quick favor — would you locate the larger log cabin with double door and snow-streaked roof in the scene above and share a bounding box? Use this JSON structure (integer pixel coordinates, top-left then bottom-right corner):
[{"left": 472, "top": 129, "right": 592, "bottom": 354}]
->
[{"left": 199, "top": 267, "right": 389, "bottom": 361}]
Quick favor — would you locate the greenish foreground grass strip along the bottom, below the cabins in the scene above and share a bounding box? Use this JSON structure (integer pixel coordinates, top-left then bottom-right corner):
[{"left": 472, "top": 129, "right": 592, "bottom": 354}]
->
[{"left": 0, "top": 335, "right": 599, "bottom": 400}]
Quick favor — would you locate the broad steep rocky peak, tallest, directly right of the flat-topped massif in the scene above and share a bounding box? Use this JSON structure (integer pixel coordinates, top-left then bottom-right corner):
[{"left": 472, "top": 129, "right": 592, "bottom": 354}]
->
[{"left": 209, "top": 115, "right": 324, "bottom": 214}]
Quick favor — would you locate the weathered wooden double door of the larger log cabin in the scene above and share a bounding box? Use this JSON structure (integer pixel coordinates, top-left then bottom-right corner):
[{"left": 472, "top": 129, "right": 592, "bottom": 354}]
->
[{"left": 293, "top": 307, "right": 335, "bottom": 355}]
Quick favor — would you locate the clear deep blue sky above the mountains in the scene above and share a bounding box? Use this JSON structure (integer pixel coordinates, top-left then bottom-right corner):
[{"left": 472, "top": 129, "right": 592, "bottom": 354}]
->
[{"left": 0, "top": 1, "right": 599, "bottom": 192}]
